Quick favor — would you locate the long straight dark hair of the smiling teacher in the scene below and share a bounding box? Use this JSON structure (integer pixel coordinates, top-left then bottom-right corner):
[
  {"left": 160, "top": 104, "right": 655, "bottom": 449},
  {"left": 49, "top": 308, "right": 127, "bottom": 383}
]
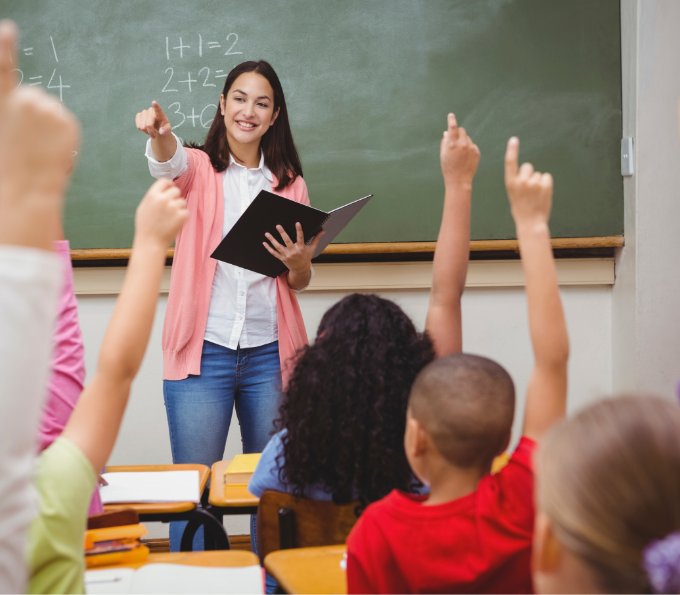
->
[{"left": 187, "top": 60, "right": 302, "bottom": 190}]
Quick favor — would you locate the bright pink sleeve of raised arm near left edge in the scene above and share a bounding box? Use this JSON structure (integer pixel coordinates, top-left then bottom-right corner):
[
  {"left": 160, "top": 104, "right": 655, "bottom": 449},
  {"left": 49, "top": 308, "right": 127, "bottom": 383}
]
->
[{"left": 40, "top": 240, "right": 85, "bottom": 450}]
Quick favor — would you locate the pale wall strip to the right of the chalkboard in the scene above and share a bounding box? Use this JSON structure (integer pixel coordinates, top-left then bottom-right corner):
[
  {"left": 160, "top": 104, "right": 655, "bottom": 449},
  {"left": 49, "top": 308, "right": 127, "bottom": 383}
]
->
[{"left": 612, "top": 0, "right": 680, "bottom": 398}]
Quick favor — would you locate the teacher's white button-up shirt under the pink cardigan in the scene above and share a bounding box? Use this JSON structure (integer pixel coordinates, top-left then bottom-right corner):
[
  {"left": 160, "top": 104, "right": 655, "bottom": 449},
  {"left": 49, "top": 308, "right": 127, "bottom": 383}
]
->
[{"left": 146, "top": 139, "right": 314, "bottom": 349}]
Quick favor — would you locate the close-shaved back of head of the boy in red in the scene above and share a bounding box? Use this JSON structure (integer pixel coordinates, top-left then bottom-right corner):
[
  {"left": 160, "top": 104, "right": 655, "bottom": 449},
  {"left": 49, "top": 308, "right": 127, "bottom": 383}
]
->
[{"left": 409, "top": 353, "right": 515, "bottom": 470}]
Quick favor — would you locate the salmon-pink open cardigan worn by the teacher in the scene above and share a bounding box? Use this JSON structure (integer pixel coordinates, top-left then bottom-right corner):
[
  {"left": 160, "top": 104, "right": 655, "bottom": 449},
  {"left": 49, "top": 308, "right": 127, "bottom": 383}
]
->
[{"left": 163, "top": 149, "right": 309, "bottom": 387}]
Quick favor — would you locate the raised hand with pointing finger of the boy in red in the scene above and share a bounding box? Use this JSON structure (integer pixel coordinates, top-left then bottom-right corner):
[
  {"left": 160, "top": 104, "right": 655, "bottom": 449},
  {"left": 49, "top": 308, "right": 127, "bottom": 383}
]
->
[{"left": 505, "top": 136, "right": 553, "bottom": 226}]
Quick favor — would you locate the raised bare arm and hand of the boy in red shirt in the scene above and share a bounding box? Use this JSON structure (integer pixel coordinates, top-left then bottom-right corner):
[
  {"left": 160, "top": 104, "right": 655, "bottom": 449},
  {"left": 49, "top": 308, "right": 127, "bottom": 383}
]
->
[{"left": 505, "top": 137, "right": 569, "bottom": 440}]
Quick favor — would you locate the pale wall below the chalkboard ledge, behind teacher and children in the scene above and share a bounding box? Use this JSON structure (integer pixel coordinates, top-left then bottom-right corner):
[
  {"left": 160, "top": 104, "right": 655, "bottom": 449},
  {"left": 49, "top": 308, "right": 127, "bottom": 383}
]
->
[{"left": 78, "top": 285, "right": 612, "bottom": 537}]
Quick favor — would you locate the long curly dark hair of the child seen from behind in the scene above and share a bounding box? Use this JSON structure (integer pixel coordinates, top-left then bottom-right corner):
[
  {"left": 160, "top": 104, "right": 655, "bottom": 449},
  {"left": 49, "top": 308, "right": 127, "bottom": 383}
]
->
[{"left": 276, "top": 294, "right": 434, "bottom": 505}]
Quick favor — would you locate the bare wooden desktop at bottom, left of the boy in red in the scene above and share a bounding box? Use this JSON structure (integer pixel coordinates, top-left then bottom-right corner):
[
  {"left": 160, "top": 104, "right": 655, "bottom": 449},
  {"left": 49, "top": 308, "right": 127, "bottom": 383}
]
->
[{"left": 264, "top": 545, "right": 347, "bottom": 595}]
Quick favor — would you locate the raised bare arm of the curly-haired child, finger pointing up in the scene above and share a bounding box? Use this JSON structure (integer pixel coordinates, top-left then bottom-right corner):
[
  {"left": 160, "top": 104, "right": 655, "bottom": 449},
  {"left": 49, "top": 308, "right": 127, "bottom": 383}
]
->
[{"left": 425, "top": 114, "right": 479, "bottom": 357}]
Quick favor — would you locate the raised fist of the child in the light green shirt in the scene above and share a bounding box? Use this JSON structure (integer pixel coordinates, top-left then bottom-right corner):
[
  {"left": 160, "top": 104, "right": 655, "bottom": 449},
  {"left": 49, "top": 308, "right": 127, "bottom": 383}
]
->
[{"left": 135, "top": 179, "right": 189, "bottom": 250}]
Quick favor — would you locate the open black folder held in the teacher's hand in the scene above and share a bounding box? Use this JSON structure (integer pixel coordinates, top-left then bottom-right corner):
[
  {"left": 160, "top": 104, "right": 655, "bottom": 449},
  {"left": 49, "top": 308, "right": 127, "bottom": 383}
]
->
[{"left": 211, "top": 190, "right": 373, "bottom": 277}]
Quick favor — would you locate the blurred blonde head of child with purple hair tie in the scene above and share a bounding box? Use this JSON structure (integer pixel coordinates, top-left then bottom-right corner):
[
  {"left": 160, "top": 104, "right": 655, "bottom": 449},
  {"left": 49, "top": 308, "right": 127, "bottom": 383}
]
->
[{"left": 537, "top": 396, "right": 680, "bottom": 595}]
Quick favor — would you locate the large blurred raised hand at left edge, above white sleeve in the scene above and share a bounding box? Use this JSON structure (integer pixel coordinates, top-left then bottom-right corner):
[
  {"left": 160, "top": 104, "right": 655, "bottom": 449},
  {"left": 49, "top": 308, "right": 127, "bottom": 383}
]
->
[{"left": 0, "top": 21, "right": 80, "bottom": 250}]
